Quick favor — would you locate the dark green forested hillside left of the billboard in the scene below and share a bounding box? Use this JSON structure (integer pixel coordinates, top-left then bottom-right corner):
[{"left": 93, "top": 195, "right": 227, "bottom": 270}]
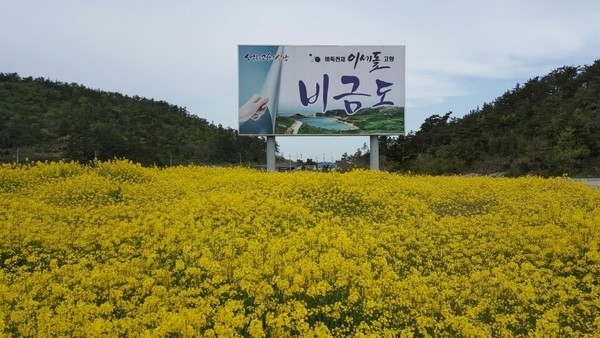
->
[{"left": 0, "top": 73, "right": 266, "bottom": 166}]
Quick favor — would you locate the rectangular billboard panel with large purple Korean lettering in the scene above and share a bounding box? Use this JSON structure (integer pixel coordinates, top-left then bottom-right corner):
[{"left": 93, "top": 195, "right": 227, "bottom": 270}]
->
[{"left": 238, "top": 45, "right": 405, "bottom": 136}]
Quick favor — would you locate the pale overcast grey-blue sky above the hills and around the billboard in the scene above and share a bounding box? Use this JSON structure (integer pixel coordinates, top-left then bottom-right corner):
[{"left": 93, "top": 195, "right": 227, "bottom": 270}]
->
[{"left": 0, "top": 0, "right": 600, "bottom": 160}]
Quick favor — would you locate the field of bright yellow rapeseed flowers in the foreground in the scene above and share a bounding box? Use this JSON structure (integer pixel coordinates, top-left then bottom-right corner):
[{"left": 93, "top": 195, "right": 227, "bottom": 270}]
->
[{"left": 0, "top": 160, "right": 600, "bottom": 337}]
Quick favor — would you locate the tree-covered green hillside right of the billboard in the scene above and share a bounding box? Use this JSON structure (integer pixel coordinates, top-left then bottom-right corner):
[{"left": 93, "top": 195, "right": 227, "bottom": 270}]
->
[{"left": 380, "top": 60, "right": 600, "bottom": 176}]
